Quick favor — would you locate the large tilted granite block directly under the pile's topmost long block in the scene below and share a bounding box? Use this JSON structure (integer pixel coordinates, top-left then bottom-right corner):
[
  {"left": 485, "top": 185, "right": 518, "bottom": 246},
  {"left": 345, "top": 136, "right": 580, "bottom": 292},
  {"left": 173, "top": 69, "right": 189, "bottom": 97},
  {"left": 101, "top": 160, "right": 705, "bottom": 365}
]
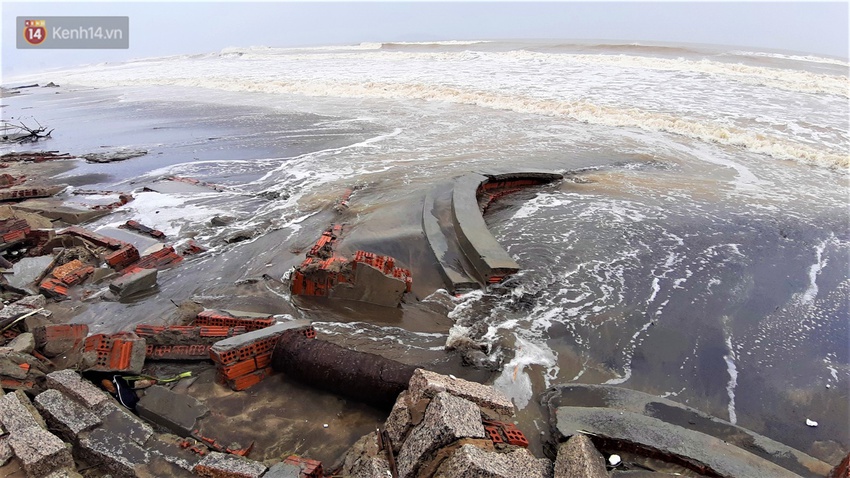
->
[{"left": 398, "top": 392, "right": 486, "bottom": 478}]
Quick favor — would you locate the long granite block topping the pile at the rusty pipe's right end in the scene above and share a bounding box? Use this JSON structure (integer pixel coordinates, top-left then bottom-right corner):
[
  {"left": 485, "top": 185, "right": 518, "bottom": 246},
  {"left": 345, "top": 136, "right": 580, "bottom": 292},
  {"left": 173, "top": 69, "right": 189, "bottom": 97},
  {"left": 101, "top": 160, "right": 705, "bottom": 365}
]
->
[{"left": 407, "top": 368, "right": 514, "bottom": 417}]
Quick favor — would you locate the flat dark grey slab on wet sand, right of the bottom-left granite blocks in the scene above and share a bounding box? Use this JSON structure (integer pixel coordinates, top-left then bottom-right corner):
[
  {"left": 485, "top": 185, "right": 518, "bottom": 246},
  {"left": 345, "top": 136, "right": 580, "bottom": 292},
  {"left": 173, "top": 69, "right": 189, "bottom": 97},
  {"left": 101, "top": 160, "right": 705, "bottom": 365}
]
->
[{"left": 136, "top": 385, "right": 208, "bottom": 437}]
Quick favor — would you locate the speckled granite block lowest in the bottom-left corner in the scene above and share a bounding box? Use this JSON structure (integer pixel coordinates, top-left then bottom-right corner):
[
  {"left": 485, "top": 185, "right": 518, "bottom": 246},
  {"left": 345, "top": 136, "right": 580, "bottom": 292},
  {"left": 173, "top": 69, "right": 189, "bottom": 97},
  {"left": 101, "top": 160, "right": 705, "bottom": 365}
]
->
[{"left": 9, "top": 427, "right": 74, "bottom": 477}]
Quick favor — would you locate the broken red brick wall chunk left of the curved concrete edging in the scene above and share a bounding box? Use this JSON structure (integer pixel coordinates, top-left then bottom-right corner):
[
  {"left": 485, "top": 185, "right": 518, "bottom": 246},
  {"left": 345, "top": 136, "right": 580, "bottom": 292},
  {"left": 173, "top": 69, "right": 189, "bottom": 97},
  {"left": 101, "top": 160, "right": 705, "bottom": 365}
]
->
[{"left": 290, "top": 224, "right": 413, "bottom": 307}]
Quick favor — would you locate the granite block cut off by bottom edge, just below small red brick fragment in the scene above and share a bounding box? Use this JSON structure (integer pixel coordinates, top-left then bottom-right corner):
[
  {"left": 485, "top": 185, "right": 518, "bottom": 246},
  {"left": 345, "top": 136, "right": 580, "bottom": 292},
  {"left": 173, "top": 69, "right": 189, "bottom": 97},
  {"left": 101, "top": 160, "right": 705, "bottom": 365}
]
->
[{"left": 434, "top": 445, "right": 552, "bottom": 478}]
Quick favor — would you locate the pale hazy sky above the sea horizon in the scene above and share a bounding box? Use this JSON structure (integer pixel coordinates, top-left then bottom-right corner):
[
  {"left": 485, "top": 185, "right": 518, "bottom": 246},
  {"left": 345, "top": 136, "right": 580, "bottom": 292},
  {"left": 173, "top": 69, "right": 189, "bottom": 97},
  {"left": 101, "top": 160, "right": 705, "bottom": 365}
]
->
[{"left": 0, "top": 1, "right": 848, "bottom": 79}]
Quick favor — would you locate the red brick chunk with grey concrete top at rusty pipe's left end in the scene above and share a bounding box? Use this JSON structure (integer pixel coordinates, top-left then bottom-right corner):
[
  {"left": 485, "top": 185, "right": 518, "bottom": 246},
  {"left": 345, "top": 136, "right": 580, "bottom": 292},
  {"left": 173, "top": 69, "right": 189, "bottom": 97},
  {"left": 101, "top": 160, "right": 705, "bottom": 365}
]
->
[{"left": 210, "top": 320, "right": 316, "bottom": 391}]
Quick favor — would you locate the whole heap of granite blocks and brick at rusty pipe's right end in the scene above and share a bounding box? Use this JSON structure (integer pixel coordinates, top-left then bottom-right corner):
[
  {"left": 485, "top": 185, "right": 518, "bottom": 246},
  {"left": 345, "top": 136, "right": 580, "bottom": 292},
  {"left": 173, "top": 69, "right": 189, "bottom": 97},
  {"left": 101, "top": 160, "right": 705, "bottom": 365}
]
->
[{"left": 340, "top": 369, "right": 544, "bottom": 478}]
